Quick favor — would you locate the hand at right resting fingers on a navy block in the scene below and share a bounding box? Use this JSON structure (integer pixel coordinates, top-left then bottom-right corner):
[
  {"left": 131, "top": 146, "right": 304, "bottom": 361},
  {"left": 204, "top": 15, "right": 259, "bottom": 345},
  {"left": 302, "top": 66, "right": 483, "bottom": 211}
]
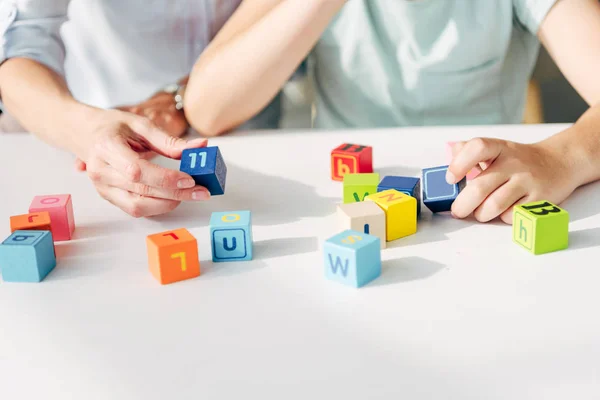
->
[{"left": 446, "top": 138, "right": 577, "bottom": 224}]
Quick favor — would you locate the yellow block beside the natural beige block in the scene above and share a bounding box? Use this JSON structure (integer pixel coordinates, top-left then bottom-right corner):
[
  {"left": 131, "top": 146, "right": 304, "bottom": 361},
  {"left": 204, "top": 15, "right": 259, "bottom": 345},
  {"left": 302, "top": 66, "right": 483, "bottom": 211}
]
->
[{"left": 366, "top": 189, "right": 417, "bottom": 242}]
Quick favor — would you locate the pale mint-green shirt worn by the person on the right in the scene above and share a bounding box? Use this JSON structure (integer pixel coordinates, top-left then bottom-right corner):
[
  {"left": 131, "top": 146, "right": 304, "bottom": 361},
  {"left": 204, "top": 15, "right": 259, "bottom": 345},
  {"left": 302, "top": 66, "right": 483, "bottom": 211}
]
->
[{"left": 309, "top": 0, "right": 556, "bottom": 129}]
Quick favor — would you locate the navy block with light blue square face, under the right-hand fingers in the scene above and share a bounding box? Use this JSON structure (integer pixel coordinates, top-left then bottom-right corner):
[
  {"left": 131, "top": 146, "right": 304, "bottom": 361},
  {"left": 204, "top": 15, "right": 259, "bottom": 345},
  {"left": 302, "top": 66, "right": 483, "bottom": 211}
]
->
[{"left": 423, "top": 165, "right": 467, "bottom": 213}]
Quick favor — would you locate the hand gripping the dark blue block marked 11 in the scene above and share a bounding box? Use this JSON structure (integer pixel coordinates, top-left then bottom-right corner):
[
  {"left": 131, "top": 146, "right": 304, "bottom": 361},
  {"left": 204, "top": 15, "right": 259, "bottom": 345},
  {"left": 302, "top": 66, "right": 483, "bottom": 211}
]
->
[{"left": 82, "top": 110, "right": 210, "bottom": 217}]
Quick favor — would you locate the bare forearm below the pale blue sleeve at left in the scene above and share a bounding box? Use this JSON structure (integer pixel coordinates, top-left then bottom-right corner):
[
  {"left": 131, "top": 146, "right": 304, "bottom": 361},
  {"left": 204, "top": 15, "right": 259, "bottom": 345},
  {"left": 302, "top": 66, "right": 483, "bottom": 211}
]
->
[{"left": 0, "top": 58, "right": 97, "bottom": 155}]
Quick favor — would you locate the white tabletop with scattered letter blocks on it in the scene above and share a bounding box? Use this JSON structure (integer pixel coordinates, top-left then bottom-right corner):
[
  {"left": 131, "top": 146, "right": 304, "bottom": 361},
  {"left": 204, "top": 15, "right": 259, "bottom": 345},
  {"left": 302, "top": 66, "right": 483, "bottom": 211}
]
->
[{"left": 0, "top": 125, "right": 600, "bottom": 400}]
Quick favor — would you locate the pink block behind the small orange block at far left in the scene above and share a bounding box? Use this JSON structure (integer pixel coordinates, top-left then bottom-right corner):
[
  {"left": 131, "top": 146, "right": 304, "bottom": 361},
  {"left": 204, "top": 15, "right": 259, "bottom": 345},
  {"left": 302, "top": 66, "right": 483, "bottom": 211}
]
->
[{"left": 29, "top": 194, "right": 75, "bottom": 242}]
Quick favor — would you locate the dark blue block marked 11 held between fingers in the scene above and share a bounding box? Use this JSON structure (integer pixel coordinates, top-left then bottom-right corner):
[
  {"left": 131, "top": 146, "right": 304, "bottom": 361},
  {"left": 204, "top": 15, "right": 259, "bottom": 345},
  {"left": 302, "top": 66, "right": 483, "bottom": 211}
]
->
[{"left": 179, "top": 146, "right": 227, "bottom": 196}]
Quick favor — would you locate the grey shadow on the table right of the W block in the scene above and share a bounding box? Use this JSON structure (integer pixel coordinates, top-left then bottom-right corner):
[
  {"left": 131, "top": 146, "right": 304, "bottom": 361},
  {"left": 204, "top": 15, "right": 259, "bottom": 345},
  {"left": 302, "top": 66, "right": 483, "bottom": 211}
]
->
[{"left": 370, "top": 257, "right": 446, "bottom": 286}]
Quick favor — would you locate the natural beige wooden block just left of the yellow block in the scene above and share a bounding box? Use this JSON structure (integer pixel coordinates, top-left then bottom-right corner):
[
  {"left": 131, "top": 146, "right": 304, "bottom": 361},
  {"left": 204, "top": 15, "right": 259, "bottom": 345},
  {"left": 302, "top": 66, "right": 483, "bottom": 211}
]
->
[{"left": 337, "top": 201, "right": 386, "bottom": 249}]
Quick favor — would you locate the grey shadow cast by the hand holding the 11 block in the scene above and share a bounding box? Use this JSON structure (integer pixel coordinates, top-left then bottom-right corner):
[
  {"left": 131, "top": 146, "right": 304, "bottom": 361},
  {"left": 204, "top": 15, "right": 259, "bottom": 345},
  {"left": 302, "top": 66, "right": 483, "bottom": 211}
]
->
[{"left": 152, "top": 164, "right": 339, "bottom": 227}]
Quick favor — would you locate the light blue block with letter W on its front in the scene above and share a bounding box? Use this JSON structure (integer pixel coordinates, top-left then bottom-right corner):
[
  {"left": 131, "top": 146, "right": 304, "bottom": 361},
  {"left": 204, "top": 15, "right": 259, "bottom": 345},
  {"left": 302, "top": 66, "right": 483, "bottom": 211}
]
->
[{"left": 323, "top": 229, "right": 381, "bottom": 288}]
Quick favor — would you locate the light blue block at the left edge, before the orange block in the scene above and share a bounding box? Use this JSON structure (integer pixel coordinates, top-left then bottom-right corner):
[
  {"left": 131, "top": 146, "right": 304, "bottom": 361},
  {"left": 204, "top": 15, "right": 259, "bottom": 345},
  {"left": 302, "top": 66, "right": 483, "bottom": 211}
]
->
[{"left": 0, "top": 230, "right": 56, "bottom": 282}]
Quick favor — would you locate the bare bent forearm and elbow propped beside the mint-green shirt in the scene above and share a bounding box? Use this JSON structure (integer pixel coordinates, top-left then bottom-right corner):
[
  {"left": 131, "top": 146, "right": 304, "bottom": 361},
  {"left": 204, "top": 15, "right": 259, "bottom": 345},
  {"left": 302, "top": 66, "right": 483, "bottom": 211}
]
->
[{"left": 185, "top": 0, "right": 345, "bottom": 135}]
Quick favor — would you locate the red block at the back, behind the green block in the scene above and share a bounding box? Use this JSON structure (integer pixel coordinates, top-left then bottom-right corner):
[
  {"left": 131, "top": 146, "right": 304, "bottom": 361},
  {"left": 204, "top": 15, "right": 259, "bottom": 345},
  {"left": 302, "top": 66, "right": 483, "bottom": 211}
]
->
[{"left": 331, "top": 143, "right": 373, "bottom": 181}]
